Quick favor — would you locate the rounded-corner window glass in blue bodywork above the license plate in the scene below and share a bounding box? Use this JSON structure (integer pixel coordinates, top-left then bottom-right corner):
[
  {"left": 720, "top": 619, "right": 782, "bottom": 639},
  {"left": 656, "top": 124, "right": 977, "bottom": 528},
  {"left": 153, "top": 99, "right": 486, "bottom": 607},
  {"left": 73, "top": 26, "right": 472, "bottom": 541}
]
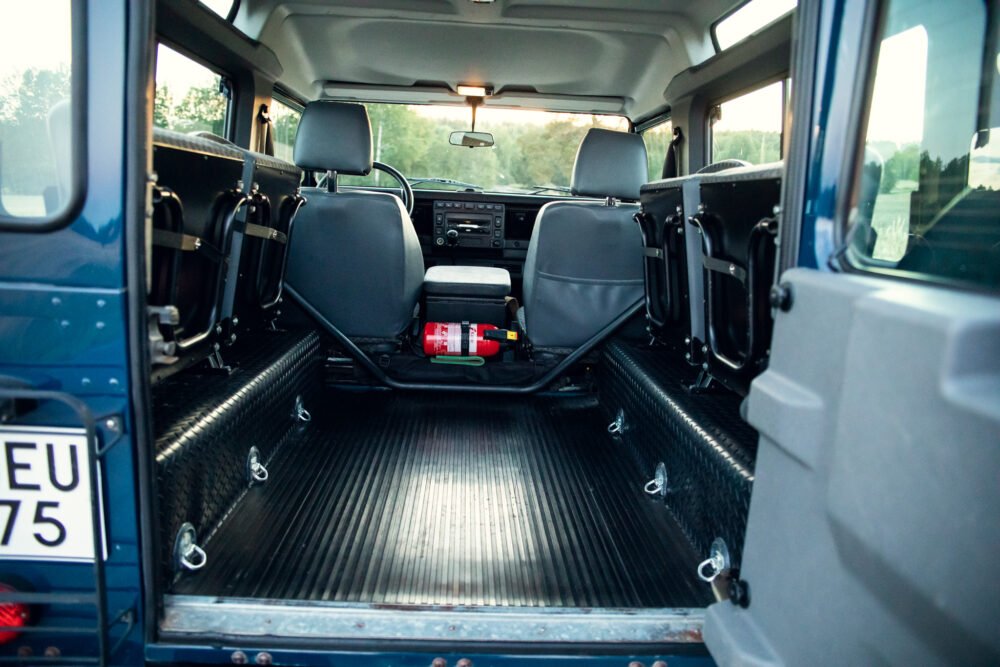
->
[{"left": 0, "top": 0, "right": 84, "bottom": 226}]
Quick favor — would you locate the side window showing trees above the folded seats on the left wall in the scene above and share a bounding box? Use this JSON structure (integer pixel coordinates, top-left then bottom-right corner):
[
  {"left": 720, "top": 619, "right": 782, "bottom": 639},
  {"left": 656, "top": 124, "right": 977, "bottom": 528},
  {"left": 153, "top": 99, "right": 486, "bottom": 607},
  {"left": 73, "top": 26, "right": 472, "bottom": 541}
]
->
[{"left": 153, "top": 44, "right": 230, "bottom": 137}]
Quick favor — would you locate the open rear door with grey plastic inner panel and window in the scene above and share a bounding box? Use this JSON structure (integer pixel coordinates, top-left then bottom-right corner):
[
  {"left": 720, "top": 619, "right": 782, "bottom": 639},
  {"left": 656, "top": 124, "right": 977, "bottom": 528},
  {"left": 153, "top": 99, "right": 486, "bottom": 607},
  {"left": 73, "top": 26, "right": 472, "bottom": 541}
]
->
[{"left": 705, "top": 0, "right": 1000, "bottom": 665}]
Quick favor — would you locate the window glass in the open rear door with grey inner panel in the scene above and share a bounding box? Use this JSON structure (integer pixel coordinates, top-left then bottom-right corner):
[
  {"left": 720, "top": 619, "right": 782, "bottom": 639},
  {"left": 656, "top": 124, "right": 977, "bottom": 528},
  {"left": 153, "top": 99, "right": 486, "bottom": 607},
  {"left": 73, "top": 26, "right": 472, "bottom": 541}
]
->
[{"left": 847, "top": 0, "right": 1000, "bottom": 289}]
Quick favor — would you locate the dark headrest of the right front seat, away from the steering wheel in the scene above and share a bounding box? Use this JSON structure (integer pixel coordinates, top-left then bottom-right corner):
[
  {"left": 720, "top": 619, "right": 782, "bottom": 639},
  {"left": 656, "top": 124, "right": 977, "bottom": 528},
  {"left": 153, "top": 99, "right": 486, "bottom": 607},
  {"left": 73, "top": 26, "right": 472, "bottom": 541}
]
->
[{"left": 572, "top": 127, "right": 647, "bottom": 200}]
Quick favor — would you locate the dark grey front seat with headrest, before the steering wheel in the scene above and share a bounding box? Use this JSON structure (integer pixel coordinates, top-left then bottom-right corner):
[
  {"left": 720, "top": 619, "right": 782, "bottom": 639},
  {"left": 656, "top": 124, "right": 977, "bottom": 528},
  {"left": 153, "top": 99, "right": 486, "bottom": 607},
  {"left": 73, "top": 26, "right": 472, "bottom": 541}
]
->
[{"left": 285, "top": 101, "right": 424, "bottom": 344}]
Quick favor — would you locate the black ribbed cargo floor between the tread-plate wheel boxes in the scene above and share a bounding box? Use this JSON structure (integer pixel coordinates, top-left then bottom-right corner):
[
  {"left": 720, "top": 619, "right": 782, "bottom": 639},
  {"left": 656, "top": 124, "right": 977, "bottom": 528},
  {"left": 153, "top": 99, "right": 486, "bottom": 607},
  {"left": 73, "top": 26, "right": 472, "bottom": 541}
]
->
[{"left": 174, "top": 393, "right": 710, "bottom": 608}]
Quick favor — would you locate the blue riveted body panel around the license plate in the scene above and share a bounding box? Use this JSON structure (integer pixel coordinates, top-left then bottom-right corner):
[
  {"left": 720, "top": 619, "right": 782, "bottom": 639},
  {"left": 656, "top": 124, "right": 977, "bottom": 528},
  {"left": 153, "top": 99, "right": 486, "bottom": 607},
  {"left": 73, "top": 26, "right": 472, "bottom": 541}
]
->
[{"left": 0, "top": 1, "right": 143, "bottom": 665}]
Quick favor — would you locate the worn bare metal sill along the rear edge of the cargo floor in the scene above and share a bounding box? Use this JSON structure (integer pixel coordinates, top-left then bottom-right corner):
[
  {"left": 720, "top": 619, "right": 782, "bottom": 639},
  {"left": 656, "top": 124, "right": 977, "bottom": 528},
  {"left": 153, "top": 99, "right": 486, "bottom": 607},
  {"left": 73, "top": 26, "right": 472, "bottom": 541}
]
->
[{"left": 160, "top": 595, "right": 705, "bottom": 645}]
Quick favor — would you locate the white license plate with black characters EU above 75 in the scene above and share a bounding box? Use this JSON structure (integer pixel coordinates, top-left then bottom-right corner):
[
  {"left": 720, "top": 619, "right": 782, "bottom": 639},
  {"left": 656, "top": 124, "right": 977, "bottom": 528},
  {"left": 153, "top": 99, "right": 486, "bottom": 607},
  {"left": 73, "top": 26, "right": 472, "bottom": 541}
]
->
[{"left": 0, "top": 426, "right": 104, "bottom": 562}]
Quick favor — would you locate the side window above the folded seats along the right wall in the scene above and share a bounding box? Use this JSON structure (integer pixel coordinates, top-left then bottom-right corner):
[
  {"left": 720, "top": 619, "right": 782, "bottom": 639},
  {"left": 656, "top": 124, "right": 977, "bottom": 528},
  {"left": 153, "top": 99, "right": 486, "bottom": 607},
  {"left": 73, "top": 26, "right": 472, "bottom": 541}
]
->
[{"left": 709, "top": 81, "right": 787, "bottom": 164}]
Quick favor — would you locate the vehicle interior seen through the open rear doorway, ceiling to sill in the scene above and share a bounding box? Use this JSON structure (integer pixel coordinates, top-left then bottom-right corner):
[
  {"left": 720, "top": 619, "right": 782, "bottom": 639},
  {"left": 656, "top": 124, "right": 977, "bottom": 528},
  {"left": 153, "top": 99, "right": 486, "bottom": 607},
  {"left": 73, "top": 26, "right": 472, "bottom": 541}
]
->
[{"left": 146, "top": 0, "right": 793, "bottom": 652}]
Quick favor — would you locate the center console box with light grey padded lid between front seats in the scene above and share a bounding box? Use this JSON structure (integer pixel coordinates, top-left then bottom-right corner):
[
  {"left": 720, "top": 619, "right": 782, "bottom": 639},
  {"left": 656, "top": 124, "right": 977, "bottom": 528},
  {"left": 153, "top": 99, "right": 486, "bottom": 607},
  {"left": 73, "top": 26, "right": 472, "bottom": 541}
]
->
[{"left": 424, "top": 265, "right": 510, "bottom": 328}]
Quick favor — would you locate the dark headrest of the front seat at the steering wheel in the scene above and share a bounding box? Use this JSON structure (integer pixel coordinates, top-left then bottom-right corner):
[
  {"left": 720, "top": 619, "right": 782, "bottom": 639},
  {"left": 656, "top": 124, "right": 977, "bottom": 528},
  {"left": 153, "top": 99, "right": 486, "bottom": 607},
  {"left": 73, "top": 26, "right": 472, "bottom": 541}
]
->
[{"left": 294, "top": 100, "right": 372, "bottom": 176}]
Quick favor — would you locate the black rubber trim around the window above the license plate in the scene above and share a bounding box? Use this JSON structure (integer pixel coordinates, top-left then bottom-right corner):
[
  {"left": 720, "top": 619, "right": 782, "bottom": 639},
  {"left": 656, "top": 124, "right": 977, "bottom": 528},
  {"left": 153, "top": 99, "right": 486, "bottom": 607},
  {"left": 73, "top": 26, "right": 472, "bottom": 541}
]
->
[{"left": 0, "top": 0, "right": 90, "bottom": 233}]
